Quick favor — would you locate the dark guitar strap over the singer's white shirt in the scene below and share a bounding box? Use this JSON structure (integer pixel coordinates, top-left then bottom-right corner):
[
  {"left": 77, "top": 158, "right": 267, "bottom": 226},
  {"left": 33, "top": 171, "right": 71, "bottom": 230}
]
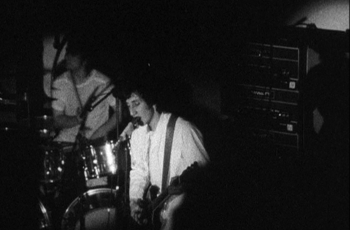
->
[{"left": 162, "top": 114, "right": 177, "bottom": 192}]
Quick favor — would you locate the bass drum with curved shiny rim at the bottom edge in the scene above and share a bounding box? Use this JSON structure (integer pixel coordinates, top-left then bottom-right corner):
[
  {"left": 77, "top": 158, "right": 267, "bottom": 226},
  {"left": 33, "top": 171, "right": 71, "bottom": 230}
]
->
[{"left": 61, "top": 188, "right": 117, "bottom": 230}]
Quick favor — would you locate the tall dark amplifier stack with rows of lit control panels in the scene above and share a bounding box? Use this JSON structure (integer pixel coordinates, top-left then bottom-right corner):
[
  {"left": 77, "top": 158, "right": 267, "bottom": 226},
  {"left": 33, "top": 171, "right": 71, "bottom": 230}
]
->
[{"left": 222, "top": 31, "right": 308, "bottom": 152}]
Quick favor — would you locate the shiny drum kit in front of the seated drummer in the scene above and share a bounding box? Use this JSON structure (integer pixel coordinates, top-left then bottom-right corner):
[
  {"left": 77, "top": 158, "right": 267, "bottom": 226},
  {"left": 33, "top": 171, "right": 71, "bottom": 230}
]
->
[{"left": 38, "top": 117, "right": 128, "bottom": 230}]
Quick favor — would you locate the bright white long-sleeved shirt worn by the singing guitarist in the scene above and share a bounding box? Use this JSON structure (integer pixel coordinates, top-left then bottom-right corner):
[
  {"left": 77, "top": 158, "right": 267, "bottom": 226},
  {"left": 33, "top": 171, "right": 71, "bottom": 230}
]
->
[{"left": 130, "top": 113, "right": 209, "bottom": 200}]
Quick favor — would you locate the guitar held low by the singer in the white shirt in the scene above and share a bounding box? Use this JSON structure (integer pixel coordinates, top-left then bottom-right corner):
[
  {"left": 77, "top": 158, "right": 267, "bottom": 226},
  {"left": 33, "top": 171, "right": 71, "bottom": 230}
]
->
[{"left": 144, "top": 162, "right": 199, "bottom": 230}]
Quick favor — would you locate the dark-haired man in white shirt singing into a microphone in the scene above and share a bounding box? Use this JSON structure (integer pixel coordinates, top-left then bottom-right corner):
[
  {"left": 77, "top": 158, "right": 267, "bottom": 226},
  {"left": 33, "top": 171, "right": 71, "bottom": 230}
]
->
[{"left": 126, "top": 73, "right": 209, "bottom": 229}]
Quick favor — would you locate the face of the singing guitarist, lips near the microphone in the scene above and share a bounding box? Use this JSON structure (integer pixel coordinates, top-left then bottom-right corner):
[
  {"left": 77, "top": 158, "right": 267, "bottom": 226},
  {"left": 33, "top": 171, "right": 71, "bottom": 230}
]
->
[{"left": 126, "top": 93, "right": 155, "bottom": 125}]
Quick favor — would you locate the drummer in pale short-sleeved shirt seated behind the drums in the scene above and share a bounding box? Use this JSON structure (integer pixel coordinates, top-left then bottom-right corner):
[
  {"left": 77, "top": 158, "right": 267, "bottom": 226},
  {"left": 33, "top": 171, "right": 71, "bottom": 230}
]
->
[{"left": 52, "top": 36, "right": 117, "bottom": 143}]
